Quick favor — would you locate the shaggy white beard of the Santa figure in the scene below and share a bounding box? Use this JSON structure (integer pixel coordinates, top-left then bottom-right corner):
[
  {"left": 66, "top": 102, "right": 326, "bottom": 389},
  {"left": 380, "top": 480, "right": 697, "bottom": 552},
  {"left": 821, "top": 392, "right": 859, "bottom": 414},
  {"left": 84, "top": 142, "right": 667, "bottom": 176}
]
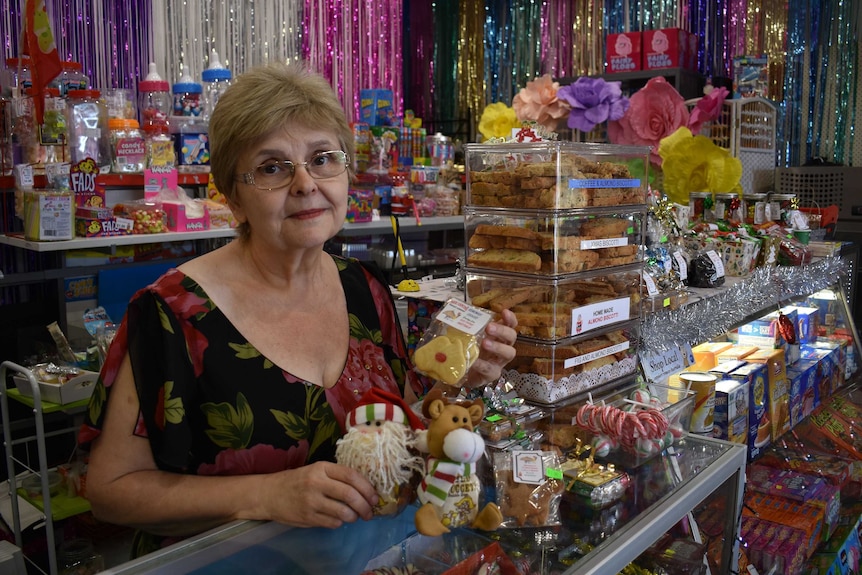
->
[{"left": 335, "top": 423, "right": 425, "bottom": 495}]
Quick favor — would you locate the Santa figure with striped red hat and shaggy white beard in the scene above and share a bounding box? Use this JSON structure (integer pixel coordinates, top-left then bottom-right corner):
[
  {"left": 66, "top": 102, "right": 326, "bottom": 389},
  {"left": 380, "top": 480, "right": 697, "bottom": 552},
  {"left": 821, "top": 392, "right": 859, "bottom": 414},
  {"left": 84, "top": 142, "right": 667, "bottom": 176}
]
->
[{"left": 335, "top": 388, "right": 425, "bottom": 515}]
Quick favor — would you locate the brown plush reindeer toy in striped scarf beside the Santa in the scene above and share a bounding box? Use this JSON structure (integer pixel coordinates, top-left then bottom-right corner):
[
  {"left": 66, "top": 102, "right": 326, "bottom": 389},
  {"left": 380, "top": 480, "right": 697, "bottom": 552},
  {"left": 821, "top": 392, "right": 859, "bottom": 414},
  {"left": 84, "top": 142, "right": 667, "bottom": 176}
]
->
[{"left": 414, "top": 390, "right": 503, "bottom": 537}]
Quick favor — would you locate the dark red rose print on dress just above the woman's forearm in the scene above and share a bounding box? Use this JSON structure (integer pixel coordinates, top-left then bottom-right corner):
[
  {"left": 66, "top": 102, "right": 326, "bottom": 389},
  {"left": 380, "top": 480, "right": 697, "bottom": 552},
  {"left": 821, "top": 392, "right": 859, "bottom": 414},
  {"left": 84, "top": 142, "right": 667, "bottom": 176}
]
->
[{"left": 198, "top": 440, "right": 308, "bottom": 475}]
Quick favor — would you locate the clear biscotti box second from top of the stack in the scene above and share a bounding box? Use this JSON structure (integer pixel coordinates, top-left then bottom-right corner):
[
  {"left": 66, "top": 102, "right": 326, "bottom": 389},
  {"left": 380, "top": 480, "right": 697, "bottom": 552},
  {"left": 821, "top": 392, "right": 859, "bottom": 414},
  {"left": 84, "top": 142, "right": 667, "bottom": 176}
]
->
[{"left": 464, "top": 208, "right": 645, "bottom": 275}]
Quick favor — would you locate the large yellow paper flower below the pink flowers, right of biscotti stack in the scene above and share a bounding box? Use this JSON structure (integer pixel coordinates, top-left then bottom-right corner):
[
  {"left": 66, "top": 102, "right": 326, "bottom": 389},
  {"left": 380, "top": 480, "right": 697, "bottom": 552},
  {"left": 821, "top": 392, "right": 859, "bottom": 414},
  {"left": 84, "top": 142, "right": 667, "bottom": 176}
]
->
[{"left": 658, "top": 127, "right": 742, "bottom": 204}]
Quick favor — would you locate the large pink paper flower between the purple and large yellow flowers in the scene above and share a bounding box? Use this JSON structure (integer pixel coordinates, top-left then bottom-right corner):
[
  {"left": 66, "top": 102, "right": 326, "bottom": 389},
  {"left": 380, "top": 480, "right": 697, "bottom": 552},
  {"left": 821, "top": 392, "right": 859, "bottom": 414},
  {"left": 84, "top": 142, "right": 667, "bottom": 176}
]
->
[{"left": 608, "top": 77, "right": 689, "bottom": 166}]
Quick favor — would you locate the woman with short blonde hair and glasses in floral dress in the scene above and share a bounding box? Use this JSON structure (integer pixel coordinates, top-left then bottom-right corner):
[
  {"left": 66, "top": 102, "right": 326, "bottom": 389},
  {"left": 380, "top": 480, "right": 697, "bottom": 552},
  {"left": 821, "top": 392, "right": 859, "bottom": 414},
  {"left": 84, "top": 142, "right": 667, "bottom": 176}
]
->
[{"left": 80, "top": 60, "right": 516, "bottom": 554}]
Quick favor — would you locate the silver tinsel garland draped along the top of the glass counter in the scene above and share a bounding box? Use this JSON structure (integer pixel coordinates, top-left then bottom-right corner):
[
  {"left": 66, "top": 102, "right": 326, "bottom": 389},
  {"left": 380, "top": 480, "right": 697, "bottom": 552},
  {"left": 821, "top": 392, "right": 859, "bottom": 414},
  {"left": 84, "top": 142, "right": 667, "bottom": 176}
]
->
[{"left": 642, "top": 257, "right": 850, "bottom": 353}]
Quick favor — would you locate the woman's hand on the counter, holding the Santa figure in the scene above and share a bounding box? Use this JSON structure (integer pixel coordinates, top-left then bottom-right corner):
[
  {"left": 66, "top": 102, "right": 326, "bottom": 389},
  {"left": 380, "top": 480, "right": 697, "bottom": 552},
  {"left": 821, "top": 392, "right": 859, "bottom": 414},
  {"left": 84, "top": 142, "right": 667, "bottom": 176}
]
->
[{"left": 260, "top": 461, "right": 378, "bottom": 529}]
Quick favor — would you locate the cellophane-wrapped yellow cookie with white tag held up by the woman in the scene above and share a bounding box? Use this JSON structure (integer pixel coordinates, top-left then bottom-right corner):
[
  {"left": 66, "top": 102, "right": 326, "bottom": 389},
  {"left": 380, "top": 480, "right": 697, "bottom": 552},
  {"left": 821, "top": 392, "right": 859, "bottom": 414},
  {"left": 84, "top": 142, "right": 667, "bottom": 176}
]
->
[{"left": 413, "top": 299, "right": 493, "bottom": 387}]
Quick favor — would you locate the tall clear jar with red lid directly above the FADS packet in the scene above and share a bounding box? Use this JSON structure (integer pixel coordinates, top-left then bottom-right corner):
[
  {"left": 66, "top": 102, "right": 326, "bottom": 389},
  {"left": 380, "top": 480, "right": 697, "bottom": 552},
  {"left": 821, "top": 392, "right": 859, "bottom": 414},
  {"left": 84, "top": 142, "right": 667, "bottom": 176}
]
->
[{"left": 66, "top": 90, "right": 111, "bottom": 174}]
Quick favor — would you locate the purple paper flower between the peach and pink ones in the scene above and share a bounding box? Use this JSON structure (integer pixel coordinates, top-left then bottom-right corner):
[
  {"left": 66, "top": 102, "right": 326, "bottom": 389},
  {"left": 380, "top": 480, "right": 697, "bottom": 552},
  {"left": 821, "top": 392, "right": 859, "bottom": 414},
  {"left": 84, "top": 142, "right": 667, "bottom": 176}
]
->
[{"left": 557, "top": 76, "right": 629, "bottom": 132}]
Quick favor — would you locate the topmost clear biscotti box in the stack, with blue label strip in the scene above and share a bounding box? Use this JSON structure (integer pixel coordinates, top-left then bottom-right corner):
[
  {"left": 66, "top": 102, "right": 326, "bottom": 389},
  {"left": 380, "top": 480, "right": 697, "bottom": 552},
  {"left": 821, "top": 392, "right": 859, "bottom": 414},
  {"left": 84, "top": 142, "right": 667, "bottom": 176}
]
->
[{"left": 464, "top": 142, "right": 649, "bottom": 209}]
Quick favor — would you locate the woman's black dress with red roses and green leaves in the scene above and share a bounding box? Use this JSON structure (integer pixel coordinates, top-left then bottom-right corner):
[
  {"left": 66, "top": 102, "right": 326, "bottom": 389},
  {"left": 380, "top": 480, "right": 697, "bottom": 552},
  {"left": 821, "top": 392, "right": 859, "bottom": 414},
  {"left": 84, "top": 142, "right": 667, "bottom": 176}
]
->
[{"left": 78, "top": 256, "right": 424, "bottom": 556}]
